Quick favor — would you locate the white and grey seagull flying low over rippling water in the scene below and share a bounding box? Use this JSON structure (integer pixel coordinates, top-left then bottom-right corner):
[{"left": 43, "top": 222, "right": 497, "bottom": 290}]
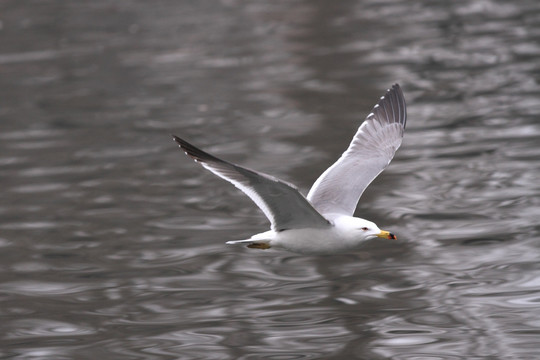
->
[{"left": 173, "top": 84, "right": 407, "bottom": 255}]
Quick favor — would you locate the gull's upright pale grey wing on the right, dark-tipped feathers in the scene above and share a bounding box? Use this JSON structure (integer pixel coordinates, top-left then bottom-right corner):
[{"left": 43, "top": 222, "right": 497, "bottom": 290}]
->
[{"left": 307, "top": 84, "right": 407, "bottom": 217}]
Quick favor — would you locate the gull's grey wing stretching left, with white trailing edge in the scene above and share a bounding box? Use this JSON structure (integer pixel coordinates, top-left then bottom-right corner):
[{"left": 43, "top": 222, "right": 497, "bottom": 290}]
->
[{"left": 173, "top": 135, "right": 330, "bottom": 231}]
